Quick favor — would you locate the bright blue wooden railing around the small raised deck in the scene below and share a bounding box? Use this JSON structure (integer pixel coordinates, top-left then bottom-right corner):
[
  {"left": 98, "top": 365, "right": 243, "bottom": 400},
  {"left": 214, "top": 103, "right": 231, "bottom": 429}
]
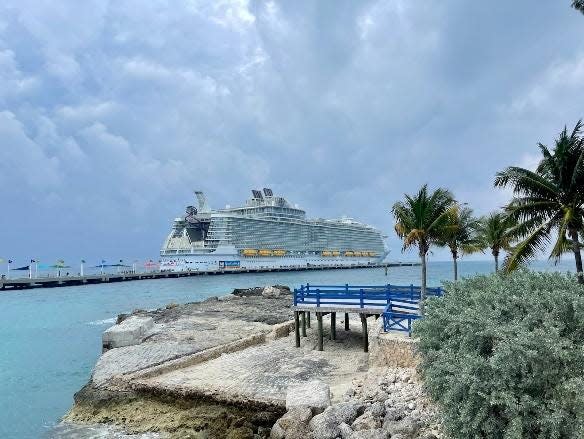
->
[{"left": 294, "top": 284, "right": 444, "bottom": 335}]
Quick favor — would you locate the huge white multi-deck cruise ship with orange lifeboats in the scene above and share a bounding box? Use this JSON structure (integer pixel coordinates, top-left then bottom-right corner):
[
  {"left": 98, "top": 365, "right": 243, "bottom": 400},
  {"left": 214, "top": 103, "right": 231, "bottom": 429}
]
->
[{"left": 160, "top": 188, "right": 387, "bottom": 271}]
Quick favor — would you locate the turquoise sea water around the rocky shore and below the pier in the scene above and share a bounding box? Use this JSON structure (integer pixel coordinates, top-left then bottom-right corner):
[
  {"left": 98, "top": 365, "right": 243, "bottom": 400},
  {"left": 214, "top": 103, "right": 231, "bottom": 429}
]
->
[{"left": 0, "top": 258, "right": 573, "bottom": 439}]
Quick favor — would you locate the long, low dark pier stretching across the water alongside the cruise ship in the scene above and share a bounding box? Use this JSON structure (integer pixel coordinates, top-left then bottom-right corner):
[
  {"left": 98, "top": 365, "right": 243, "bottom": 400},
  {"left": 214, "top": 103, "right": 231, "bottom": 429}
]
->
[{"left": 0, "top": 262, "right": 419, "bottom": 291}]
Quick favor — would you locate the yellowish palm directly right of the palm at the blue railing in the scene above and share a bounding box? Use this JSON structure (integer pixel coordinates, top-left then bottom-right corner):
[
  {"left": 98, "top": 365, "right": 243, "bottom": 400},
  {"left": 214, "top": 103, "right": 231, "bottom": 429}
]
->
[{"left": 440, "top": 204, "right": 482, "bottom": 281}]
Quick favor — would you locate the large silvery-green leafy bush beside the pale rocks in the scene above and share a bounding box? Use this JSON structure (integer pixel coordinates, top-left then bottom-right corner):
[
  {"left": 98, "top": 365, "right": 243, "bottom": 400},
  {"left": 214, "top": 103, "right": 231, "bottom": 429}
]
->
[{"left": 414, "top": 271, "right": 584, "bottom": 439}]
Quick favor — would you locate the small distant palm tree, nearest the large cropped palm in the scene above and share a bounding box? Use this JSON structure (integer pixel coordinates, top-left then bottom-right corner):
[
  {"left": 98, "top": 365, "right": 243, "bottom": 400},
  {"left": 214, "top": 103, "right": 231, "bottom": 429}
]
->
[{"left": 477, "top": 212, "right": 517, "bottom": 271}]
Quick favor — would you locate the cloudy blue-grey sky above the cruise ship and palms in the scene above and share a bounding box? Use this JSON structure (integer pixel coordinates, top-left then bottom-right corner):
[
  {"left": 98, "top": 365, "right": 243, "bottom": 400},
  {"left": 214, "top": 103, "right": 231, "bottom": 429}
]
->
[{"left": 0, "top": 0, "right": 584, "bottom": 262}]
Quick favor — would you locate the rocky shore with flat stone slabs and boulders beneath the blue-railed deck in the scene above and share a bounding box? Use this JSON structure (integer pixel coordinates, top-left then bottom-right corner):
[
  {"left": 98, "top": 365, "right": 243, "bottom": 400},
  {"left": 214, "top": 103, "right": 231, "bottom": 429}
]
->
[{"left": 65, "top": 286, "right": 440, "bottom": 439}]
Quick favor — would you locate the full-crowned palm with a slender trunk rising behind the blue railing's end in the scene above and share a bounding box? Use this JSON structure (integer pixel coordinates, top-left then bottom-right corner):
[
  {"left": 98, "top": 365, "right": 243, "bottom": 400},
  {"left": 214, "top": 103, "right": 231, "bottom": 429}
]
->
[{"left": 392, "top": 185, "right": 455, "bottom": 314}]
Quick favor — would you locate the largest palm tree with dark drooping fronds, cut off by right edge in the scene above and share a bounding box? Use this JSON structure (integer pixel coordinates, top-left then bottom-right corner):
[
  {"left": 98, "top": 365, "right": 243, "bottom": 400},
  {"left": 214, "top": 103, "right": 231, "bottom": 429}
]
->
[{"left": 495, "top": 120, "right": 584, "bottom": 284}]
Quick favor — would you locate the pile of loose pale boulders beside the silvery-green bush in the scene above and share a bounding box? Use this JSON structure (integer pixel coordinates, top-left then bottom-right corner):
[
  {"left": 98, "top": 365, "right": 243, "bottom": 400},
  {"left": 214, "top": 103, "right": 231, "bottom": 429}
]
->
[{"left": 271, "top": 368, "right": 442, "bottom": 439}]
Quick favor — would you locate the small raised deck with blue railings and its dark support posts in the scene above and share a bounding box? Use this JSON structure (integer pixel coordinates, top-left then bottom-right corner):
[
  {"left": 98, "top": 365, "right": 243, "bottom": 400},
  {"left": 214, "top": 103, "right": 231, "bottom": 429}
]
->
[{"left": 293, "top": 284, "right": 443, "bottom": 352}]
